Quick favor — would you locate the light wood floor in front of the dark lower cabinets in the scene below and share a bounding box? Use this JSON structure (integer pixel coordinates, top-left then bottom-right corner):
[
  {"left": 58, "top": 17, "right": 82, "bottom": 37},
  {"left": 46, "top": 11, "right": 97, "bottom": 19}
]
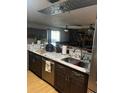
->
[{"left": 27, "top": 70, "right": 58, "bottom": 93}]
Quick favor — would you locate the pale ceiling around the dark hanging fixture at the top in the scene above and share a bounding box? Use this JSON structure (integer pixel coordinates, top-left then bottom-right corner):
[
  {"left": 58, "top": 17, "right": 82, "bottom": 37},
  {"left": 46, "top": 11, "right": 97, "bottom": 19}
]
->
[{"left": 27, "top": 0, "right": 97, "bottom": 27}]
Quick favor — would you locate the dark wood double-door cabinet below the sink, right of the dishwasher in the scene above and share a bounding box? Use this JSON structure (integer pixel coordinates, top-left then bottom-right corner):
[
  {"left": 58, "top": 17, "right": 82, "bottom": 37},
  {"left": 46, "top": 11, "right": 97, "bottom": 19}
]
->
[{"left": 55, "top": 63, "right": 88, "bottom": 93}]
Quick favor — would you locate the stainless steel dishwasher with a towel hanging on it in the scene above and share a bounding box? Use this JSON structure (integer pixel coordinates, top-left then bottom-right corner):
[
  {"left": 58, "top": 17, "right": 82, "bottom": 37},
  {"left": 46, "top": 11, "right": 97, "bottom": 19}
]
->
[{"left": 42, "top": 58, "right": 55, "bottom": 85}]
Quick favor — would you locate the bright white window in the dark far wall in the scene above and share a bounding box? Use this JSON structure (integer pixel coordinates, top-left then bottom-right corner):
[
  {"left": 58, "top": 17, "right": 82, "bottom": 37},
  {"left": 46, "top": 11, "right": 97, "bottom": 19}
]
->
[{"left": 51, "top": 30, "right": 60, "bottom": 46}]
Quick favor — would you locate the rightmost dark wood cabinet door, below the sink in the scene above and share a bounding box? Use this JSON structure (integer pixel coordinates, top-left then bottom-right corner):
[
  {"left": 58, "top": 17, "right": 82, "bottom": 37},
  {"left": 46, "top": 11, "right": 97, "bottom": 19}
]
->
[{"left": 69, "top": 71, "right": 88, "bottom": 93}]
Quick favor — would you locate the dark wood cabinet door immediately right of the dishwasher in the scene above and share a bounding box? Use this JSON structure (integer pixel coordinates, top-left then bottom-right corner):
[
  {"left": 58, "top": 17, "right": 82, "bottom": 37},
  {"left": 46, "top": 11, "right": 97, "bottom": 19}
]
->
[{"left": 55, "top": 64, "right": 66, "bottom": 93}]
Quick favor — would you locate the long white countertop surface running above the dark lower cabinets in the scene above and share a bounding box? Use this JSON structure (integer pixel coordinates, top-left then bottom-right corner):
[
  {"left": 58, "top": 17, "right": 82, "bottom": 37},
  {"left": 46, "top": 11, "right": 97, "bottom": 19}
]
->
[{"left": 28, "top": 49, "right": 90, "bottom": 74}]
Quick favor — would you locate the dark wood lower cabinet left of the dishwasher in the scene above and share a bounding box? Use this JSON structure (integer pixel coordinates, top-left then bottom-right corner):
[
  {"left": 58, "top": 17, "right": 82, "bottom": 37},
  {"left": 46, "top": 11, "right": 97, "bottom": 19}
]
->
[{"left": 29, "top": 52, "right": 42, "bottom": 78}]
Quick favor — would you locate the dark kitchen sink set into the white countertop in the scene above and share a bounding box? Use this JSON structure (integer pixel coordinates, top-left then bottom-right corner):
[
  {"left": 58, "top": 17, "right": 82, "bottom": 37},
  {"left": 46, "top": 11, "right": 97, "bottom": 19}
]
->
[{"left": 62, "top": 57, "right": 86, "bottom": 67}]
